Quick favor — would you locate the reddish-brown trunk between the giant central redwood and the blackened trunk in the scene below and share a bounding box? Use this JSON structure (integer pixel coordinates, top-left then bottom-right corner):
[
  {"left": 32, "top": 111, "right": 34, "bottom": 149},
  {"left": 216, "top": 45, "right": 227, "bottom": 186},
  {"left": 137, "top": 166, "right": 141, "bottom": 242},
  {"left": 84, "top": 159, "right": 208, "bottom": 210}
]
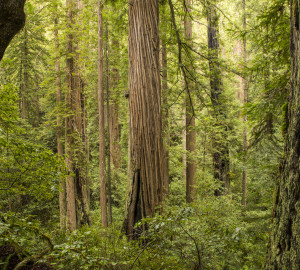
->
[{"left": 184, "top": 0, "right": 197, "bottom": 203}]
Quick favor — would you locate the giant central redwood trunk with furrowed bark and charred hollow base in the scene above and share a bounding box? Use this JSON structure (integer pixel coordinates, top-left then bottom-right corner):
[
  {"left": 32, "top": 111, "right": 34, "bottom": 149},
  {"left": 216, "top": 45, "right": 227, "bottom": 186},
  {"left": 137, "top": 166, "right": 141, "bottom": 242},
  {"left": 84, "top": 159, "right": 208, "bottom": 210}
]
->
[{"left": 124, "top": 0, "right": 168, "bottom": 239}]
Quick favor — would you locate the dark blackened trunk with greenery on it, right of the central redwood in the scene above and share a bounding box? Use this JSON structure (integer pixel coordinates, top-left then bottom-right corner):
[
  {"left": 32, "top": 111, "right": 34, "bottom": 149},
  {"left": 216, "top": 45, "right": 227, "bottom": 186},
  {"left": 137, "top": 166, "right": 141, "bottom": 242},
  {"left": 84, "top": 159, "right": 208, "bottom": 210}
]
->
[{"left": 207, "top": 4, "right": 230, "bottom": 196}]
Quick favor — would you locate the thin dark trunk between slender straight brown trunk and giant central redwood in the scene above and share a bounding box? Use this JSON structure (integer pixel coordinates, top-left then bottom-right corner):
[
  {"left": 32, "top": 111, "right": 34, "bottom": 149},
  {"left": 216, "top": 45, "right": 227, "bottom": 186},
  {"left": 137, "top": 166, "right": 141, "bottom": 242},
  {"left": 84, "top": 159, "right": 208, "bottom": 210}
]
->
[{"left": 105, "top": 21, "right": 112, "bottom": 224}]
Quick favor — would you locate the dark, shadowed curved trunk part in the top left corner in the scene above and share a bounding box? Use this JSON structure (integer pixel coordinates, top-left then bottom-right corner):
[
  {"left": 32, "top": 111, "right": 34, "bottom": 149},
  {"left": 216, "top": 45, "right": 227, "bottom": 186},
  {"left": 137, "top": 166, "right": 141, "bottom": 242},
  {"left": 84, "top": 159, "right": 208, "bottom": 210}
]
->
[{"left": 0, "top": 0, "right": 25, "bottom": 61}]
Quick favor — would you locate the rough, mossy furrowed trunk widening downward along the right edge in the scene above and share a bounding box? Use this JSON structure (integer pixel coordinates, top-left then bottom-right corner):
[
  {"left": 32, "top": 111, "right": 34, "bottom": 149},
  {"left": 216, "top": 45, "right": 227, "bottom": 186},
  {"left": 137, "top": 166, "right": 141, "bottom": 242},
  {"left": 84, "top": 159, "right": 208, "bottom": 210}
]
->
[{"left": 265, "top": 0, "right": 300, "bottom": 270}]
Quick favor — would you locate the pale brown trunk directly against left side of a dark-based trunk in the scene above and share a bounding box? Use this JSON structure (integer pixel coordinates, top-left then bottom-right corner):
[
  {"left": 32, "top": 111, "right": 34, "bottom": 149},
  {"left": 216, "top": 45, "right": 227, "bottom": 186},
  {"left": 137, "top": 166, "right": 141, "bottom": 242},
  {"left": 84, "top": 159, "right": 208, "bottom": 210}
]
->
[{"left": 65, "top": 0, "right": 77, "bottom": 231}]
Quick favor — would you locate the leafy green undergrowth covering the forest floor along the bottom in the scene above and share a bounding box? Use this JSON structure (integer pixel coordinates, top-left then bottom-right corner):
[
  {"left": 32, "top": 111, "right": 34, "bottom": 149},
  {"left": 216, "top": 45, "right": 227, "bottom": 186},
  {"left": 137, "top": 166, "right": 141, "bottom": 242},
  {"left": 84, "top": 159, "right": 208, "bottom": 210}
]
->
[{"left": 0, "top": 196, "right": 269, "bottom": 269}]
